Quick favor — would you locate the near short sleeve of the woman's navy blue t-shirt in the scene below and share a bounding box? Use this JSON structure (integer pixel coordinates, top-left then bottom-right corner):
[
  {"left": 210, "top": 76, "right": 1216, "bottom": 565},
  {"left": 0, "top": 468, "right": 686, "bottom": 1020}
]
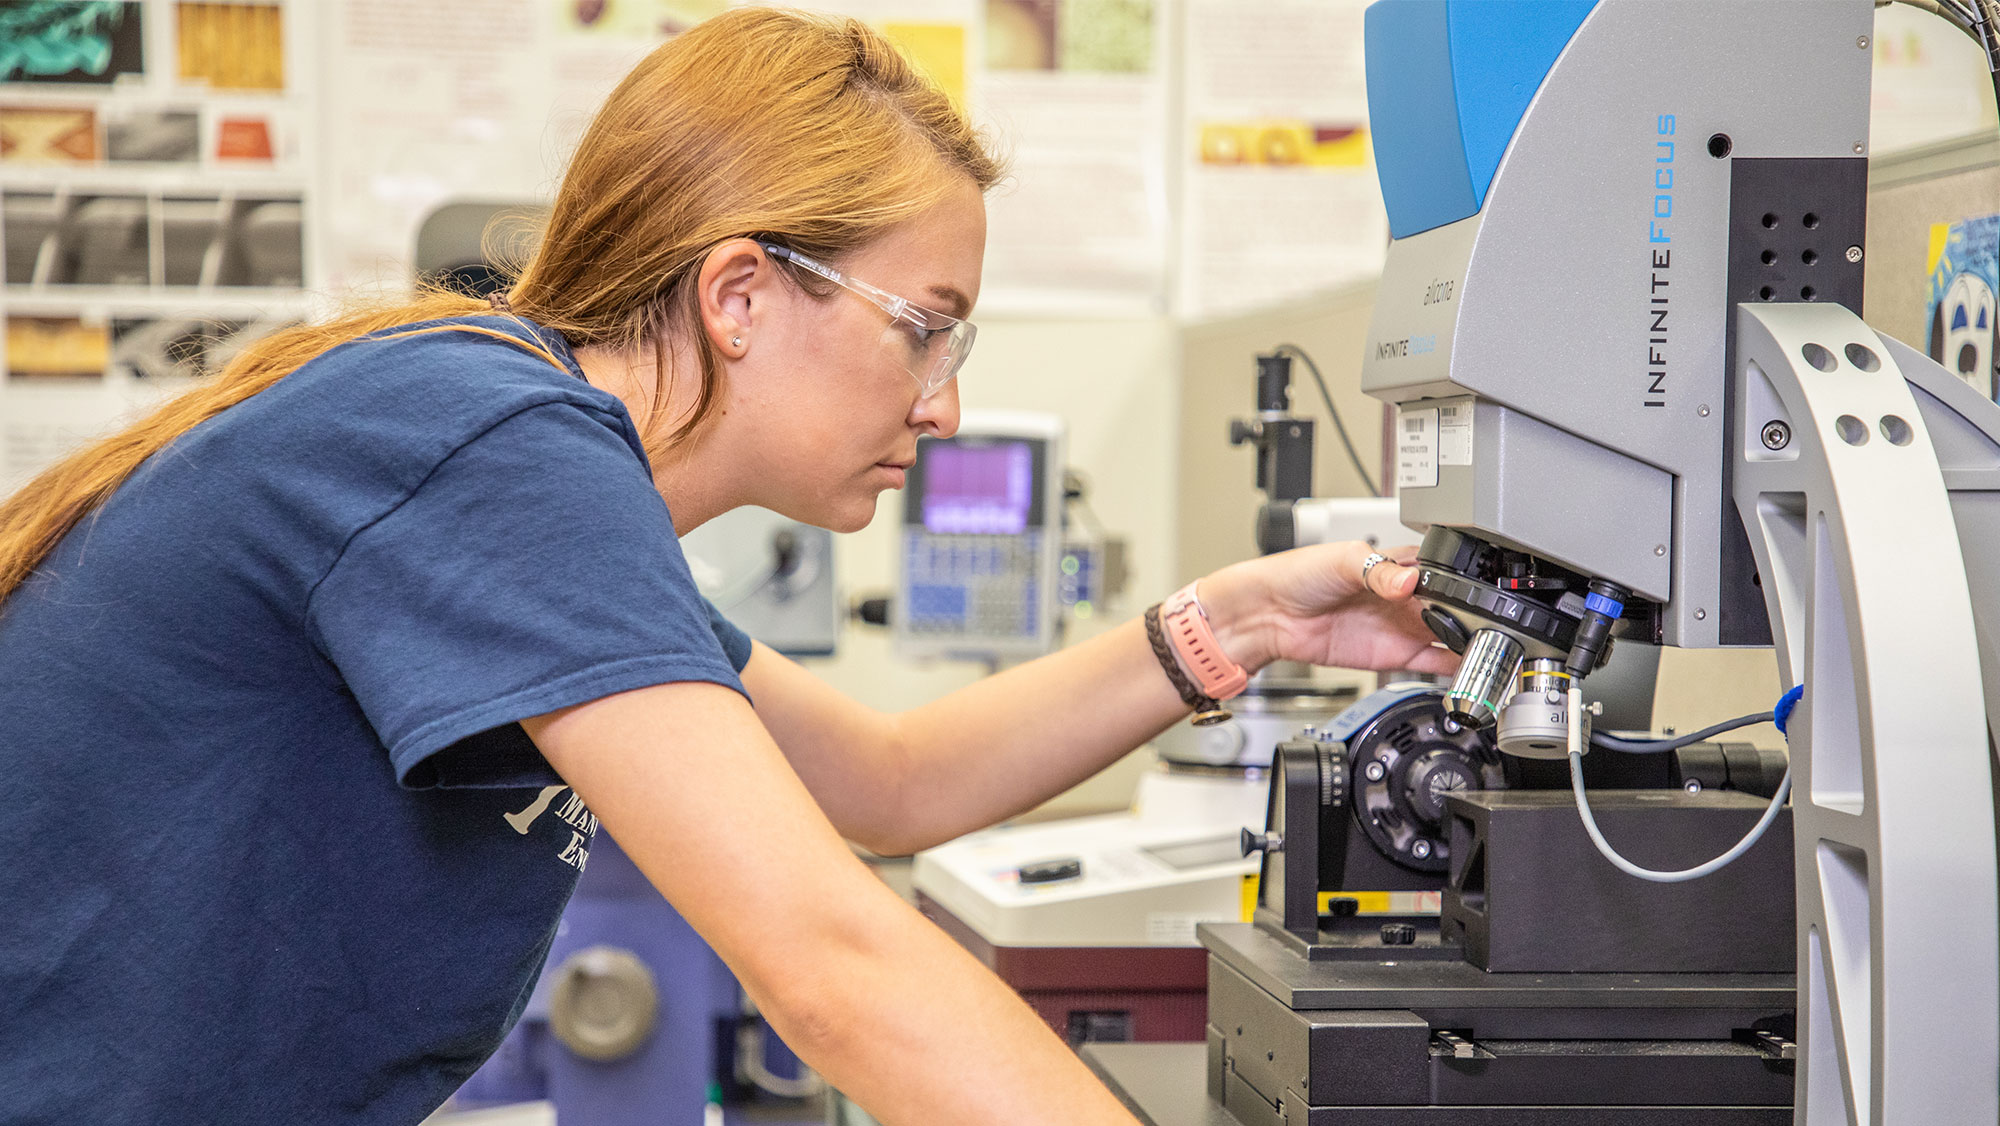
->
[{"left": 308, "top": 402, "right": 750, "bottom": 788}]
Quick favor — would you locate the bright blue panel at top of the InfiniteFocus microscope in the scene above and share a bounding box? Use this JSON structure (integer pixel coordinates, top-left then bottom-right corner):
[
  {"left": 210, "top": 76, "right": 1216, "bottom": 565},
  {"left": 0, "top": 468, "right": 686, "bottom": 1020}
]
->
[{"left": 1364, "top": 0, "right": 1598, "bottom": 238}]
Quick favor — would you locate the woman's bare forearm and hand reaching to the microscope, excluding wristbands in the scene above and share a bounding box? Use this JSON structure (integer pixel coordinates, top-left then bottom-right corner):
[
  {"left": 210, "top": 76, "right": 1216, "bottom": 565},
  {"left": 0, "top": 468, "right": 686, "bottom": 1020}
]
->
[{"left": 744, "top": 544, "right": 1456, "bottom": 854}]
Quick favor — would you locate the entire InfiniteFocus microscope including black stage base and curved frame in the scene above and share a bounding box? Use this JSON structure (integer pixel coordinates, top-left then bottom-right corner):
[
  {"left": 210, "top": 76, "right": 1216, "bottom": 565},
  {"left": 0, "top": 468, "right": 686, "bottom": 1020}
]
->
[{"left": 1092, "top": 0, "right": 2000, "bottom": 1126}]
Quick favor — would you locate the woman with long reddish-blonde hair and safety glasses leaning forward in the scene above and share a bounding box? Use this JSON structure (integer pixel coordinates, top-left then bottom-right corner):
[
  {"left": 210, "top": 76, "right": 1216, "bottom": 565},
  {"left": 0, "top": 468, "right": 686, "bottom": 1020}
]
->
[{"left": 0, "top": 10, "right": 1448, "bottom": 1124}]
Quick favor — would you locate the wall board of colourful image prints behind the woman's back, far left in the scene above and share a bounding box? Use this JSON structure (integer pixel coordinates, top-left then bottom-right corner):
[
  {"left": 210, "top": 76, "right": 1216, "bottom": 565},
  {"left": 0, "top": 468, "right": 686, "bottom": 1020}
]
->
[{"left": 0, "top": 0, "right": 320, "bottom": 492}]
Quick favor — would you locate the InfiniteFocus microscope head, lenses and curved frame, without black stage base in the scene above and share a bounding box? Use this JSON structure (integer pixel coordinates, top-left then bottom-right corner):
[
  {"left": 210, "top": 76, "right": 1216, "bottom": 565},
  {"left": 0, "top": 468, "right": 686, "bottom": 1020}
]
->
[{"left": 1362, "top": 0, "right": 2000, "bottom": 1122}]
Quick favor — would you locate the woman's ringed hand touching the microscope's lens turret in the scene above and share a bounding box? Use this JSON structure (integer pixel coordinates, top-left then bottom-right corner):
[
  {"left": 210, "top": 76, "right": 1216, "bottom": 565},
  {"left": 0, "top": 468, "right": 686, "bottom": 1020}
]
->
[{"left": 1198, "top": 542, "right": 1458, "bottom": 672}]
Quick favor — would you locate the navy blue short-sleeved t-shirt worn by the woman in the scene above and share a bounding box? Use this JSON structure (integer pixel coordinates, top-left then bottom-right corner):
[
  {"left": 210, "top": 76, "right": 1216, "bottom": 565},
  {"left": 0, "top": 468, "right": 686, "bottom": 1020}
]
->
[{"left": 0, "top": 318, "right": 750, "bottom": 1126}]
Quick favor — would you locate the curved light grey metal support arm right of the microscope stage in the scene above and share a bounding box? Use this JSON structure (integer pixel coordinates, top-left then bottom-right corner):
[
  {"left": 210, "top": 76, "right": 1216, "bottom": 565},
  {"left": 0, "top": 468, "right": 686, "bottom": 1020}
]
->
[{"left": 1732, "top": 304, "right": 2000, "bottom": 1126}]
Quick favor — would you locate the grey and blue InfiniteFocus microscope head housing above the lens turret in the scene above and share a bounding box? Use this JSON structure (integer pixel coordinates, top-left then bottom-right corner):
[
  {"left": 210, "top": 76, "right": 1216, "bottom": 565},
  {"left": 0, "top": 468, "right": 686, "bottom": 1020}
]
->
[{"left": 1362, "top": 0, "right": 1872, "bottom": 648}]
